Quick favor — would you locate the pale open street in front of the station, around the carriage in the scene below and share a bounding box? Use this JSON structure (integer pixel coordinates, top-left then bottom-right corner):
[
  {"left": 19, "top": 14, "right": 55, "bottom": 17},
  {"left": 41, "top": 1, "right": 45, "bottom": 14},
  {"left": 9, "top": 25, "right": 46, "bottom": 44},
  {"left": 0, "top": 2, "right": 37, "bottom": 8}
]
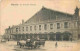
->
[{"left": 0, "top": 41, "right": 80, "bottom": 51}]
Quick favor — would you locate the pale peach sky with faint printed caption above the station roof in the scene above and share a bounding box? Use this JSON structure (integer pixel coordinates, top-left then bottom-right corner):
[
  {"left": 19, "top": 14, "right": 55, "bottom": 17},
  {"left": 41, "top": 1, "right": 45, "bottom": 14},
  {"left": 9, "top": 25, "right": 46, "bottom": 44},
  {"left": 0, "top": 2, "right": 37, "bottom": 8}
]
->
[{"left": 0, "top": 0, "right": 80, "bottom": 35}]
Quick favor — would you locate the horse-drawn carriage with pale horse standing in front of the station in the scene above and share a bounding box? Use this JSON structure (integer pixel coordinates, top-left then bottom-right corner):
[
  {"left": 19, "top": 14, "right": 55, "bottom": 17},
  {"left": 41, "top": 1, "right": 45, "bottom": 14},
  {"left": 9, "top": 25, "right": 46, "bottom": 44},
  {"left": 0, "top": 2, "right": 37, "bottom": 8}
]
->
[{"left": 17, "top": 39, "right": 45, "bottom": 48}]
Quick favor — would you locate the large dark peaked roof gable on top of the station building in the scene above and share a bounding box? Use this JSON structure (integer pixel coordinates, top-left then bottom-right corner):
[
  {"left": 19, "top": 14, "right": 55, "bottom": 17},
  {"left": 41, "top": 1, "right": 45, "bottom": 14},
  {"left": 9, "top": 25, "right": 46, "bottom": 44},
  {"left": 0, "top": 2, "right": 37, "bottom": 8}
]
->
[{"left": 25, "top": 7, "right": 73, "bottom": 23}]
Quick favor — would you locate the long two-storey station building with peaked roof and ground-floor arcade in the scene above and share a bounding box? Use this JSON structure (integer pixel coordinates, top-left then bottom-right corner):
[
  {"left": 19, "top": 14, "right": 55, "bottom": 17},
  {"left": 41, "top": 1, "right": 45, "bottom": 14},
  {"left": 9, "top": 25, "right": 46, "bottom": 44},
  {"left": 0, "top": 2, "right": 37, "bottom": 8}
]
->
[{"left": 4, "top": 7, "right": 80, "bottom": 41}]
